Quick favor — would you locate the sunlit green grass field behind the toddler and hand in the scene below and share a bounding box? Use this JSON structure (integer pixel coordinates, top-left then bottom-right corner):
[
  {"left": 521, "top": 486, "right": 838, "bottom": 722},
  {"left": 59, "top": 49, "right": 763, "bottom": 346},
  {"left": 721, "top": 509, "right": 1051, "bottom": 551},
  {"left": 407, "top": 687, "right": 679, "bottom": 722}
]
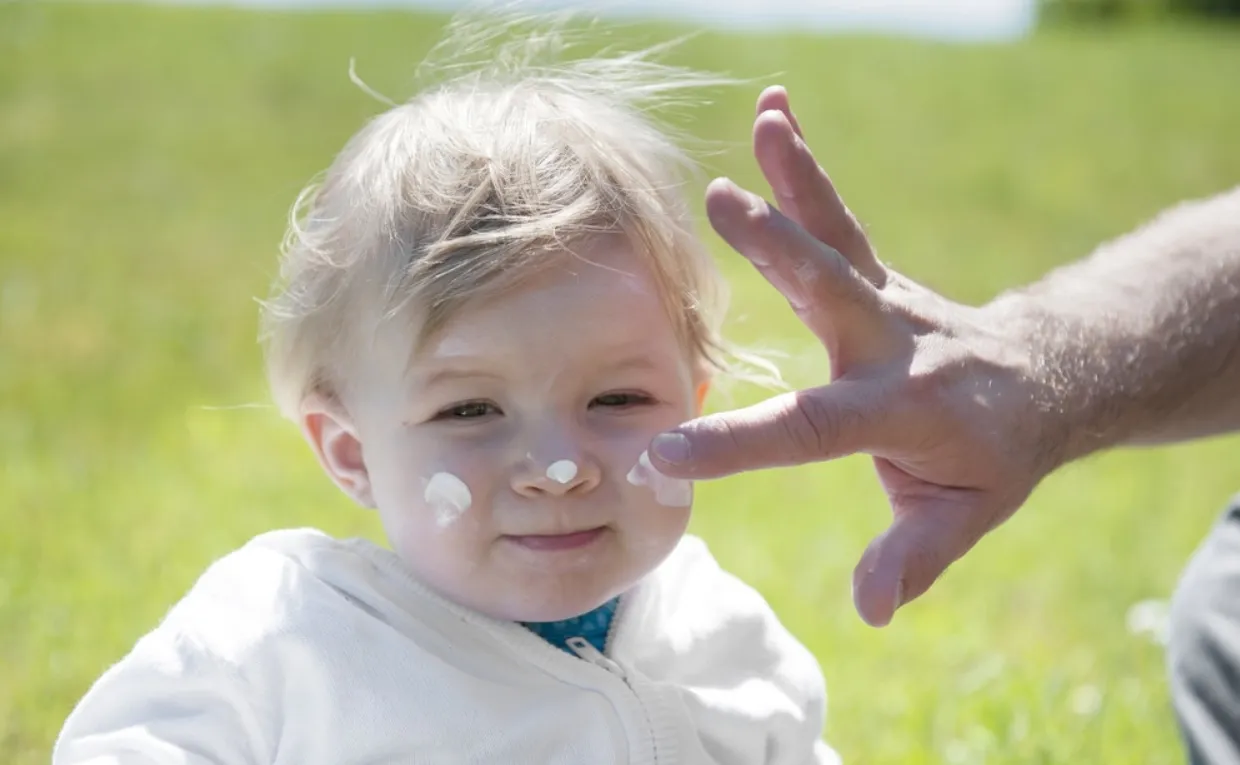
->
[{"left": 0, "top": 1, "right": 1240, "bottom": 765}]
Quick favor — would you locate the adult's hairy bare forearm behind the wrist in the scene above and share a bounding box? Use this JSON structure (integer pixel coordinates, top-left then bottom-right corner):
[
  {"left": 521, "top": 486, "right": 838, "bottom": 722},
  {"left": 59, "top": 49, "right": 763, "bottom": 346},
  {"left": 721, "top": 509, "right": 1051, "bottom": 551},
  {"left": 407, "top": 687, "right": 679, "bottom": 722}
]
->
[{"left": 987, "top": 188, "right": 1240, "bottom": 461}]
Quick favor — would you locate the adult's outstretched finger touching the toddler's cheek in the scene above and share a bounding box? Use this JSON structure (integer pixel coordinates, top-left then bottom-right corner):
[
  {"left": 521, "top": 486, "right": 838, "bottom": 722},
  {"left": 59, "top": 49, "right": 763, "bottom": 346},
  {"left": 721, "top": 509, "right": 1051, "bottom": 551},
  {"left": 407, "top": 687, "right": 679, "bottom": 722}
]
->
[{"left": 650, "top": 379, "right": 887, "bottom": 479}]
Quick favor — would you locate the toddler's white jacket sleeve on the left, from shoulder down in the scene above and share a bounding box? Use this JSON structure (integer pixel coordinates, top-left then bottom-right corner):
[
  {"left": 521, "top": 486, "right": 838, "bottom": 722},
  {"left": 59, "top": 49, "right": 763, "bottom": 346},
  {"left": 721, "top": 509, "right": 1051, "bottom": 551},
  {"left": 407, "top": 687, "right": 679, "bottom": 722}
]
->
[{"left": 52, "top": 548, "right": 300, "bottom": 765}]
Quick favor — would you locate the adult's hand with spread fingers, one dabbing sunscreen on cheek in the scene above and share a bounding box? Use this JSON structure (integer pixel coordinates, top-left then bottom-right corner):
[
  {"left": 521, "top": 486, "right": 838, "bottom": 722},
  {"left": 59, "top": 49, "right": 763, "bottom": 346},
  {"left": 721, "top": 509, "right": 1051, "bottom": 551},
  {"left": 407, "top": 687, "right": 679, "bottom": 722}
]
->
[{"left": 651, "top": 87, "right": 1063, "bottom": 626}]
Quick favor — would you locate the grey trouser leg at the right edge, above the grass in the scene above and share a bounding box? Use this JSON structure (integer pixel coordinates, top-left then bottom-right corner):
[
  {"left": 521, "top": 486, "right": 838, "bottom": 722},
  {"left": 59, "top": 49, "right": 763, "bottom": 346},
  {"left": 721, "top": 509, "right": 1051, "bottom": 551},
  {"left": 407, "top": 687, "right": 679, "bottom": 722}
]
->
[{"left": 1167, "top": 496, "right": 1240, "bottom": 765}]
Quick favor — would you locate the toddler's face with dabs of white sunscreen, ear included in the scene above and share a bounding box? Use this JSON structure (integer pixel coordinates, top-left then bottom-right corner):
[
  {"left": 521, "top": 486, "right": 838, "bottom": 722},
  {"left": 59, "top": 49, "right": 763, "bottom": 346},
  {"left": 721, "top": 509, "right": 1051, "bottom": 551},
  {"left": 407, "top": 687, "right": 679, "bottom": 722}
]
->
[{"left": 306, "top": 239, "right": 699, "bottom": 621}]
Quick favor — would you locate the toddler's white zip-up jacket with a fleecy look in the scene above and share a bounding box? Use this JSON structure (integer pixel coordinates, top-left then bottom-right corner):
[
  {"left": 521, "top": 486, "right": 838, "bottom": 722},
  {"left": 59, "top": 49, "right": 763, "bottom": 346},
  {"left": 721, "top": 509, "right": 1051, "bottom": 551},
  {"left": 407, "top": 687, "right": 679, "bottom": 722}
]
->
[{"left": 52, "top": 529, "right": 838, "bottom": 765}]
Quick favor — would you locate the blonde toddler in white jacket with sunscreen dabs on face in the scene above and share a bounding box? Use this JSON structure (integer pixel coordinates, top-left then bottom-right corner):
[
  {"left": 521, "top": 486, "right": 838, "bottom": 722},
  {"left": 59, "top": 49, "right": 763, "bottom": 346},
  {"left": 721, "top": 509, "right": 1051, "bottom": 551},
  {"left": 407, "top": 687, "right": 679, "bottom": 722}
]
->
[{"left": 53, "top": 16, "right": 837, "bottom": 765}]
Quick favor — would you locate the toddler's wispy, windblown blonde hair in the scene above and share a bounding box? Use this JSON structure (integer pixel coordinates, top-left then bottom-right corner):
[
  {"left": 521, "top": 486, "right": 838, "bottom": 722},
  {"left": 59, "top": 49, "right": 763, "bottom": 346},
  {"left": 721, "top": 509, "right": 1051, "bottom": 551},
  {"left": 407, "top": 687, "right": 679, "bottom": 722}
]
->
[{"left": 262, "top": 11, "right": 777, "bottom": 419}]
